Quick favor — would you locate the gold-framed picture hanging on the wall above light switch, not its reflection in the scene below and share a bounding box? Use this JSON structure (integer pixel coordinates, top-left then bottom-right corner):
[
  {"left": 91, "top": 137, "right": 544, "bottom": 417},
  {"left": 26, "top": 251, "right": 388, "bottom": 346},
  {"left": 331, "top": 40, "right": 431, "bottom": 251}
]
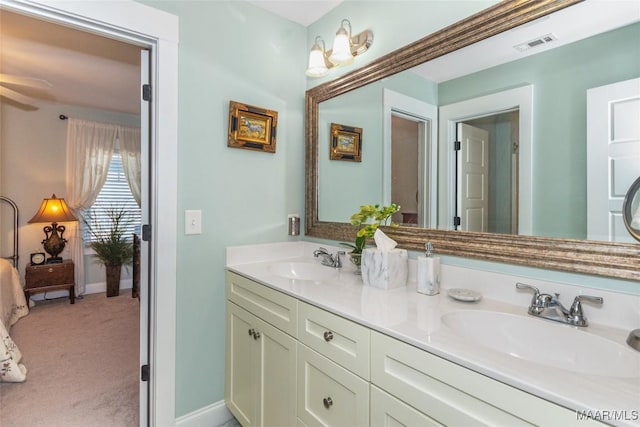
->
[{"left": 227, "top": 101, "right": 278, "bottom": 153}]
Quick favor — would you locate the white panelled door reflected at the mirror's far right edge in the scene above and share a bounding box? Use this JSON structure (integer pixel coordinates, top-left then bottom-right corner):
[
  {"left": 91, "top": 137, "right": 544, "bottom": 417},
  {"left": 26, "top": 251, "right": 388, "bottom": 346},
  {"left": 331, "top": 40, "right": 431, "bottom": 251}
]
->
[{"left": 587, "top": 79, "right": 640, "bottom": 242}]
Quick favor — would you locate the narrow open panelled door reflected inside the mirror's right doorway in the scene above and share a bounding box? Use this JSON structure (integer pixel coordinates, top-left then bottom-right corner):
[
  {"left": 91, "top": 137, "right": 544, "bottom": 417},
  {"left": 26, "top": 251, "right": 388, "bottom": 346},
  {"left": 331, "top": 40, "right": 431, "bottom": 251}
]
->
[{"left": 456, "top": 123, "right": 489, "bottom": 232}]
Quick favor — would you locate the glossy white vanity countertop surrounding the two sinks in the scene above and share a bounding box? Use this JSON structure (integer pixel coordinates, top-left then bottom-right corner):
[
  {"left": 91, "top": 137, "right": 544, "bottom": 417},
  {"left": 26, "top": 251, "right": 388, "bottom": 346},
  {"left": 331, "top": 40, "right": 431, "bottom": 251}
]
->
[{"left": 227, "top": 245, "right": 640, "bottom": 426}]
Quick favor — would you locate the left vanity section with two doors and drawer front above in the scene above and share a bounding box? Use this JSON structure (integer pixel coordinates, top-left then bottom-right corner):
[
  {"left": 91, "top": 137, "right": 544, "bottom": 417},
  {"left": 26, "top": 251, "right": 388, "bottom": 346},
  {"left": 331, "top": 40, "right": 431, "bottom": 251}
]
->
[{"left": 225, "top": 272, "right": 297, "bottom": 427}]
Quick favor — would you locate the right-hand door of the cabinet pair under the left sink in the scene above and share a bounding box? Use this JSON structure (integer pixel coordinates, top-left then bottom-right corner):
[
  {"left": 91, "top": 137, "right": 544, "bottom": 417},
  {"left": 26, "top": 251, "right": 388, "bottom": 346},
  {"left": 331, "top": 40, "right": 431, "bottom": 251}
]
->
[{"left": 255, "top": 318, "right": 297, "bottom": 427}]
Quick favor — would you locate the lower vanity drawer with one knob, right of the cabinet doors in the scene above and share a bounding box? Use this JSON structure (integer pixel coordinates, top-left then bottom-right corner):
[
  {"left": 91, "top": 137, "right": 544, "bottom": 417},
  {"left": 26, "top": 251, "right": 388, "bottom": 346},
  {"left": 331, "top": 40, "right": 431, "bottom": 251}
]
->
[{"left": 298, "top": 343, "right": 369, "bottom": 427}]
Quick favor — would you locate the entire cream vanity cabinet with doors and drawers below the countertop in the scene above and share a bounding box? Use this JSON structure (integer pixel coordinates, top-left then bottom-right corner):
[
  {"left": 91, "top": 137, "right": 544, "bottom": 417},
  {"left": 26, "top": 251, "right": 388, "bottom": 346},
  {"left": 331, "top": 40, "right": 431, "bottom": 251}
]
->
[{"left": 225, "top": 272, "right": 602, "bottom": 427}]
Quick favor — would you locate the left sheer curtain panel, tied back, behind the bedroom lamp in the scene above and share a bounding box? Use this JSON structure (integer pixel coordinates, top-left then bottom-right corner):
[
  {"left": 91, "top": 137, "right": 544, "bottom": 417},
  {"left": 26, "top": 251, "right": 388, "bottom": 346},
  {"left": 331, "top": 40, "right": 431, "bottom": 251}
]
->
[{"left": 66, "top": 118, "right": 118, "bottom": 295}]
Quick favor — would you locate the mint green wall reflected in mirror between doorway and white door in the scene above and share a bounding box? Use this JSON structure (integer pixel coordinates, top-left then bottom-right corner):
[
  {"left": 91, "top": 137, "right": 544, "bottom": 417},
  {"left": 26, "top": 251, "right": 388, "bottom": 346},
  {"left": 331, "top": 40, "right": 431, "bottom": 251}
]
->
[{"left": 438, "top": 24, "right": 640, "bottom": 239}]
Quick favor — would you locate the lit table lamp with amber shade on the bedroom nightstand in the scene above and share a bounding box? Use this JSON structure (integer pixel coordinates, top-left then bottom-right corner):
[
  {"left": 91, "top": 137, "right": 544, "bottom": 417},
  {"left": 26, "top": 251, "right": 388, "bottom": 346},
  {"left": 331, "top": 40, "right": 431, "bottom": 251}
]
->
[{"left": 29, "top": 194, "right": 78, "bottom": 264}]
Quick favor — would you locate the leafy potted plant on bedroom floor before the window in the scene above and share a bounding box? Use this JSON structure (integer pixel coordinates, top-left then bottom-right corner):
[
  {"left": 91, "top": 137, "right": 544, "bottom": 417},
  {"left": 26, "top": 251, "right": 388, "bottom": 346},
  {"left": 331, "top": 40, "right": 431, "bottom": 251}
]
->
[{"left": 83, "top": 209, "right": 133, "bottom": 297}]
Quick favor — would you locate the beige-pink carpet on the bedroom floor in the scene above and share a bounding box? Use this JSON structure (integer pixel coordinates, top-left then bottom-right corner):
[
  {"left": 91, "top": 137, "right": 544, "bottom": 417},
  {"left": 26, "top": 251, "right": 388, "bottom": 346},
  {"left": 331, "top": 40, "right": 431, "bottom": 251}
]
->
[{"left": 0, "top": 292, "right": 139, "bottom": 427}]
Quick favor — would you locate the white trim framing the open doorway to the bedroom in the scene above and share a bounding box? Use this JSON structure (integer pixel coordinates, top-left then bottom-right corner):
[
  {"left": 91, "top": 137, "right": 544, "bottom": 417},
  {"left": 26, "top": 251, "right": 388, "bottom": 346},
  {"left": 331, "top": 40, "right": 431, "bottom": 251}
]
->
[{"left": 0, "top": 0, "right": 178, "bottom": 425}]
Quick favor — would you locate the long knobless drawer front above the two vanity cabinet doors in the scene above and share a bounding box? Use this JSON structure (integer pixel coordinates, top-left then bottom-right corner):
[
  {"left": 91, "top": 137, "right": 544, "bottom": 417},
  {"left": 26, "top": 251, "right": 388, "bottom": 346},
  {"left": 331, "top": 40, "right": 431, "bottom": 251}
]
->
[{"left": 226, "top": 271, "right": 298, "bottom": 338}]
